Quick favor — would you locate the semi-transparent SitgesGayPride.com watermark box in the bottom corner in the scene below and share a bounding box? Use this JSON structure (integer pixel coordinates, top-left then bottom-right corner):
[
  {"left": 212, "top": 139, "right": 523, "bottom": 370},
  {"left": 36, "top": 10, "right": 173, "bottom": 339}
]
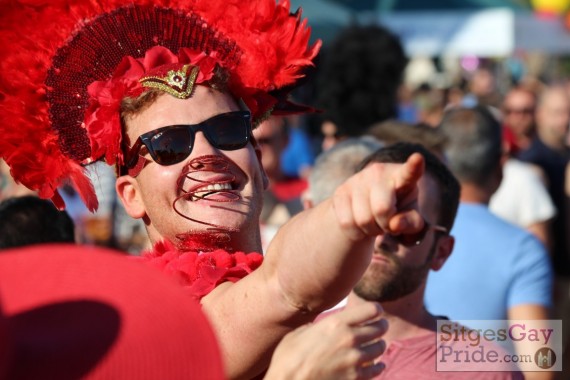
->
[{"left": 436, "top": 320, "right": 562, "bottom": 372}]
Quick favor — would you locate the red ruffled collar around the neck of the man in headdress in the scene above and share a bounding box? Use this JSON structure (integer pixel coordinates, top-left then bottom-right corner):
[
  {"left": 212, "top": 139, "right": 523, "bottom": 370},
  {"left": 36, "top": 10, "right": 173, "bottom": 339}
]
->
[{"left": 136, "top": 241, "right": 263, "bottom": 300}]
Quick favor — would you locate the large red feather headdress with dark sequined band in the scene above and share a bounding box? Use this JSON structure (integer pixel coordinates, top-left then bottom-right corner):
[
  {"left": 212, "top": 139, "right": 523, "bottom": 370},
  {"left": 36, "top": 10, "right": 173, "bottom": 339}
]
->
[{"left": 0, "top": 0, "right": 320, "bottom": 210}]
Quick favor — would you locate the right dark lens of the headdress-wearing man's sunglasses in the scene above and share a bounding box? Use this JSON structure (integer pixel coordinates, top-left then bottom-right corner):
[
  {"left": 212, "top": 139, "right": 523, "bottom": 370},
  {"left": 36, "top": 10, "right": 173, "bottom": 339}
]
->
[{"left": 205, "top": 113, "right": 249, "bottom": 150}]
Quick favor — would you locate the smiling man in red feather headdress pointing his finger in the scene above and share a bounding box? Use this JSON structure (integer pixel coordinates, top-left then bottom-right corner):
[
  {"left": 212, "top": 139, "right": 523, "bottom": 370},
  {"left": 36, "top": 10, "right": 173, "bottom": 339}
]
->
[{"left": 0, "top": 0, "right": 424, "bottom": 378}]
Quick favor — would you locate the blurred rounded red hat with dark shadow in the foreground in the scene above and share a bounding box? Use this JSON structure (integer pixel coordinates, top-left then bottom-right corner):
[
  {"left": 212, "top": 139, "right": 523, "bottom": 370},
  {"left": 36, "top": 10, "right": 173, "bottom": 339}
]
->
[{"left": 0, "top": 245, "right": 224, "bottom": 380}]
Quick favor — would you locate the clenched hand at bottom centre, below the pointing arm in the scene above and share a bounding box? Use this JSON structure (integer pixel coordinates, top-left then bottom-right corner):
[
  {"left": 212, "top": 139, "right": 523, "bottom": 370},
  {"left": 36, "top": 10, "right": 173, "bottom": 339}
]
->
[{"left": 265, "top": 302, "right": 387, "bottom": 380}]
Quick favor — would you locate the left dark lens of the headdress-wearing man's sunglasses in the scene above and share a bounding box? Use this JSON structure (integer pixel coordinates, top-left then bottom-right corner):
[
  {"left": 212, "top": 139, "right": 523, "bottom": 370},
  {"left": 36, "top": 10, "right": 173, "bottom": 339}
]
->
[{"left": 150, "top": 127, "right": 194, "bottom": 165}]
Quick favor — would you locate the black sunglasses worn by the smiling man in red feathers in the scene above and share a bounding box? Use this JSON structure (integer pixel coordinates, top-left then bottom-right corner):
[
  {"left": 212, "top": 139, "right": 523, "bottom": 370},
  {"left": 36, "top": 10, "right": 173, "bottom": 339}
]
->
[{"left": 125, "top": 111, "right": 251, "bottom": 168}]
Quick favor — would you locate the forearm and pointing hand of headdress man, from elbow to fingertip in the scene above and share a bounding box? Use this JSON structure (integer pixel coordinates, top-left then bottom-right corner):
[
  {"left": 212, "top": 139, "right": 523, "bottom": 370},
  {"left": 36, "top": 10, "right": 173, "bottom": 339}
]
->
[{"left": 264, "top": 155, "right": 423, "bottom": 314}]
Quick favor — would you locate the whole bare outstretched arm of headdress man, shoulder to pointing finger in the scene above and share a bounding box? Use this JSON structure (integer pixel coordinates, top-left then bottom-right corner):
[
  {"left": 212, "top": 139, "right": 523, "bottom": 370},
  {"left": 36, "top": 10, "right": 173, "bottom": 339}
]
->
[{"left": 202, "top": 155, "right": 424, "bottom": 378}]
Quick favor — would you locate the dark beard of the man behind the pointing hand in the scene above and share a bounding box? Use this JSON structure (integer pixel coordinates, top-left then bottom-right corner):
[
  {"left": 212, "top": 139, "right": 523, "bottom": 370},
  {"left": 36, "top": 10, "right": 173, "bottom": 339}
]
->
[{"left": 354, "top": 240, "right": 437, "bottom": 302}]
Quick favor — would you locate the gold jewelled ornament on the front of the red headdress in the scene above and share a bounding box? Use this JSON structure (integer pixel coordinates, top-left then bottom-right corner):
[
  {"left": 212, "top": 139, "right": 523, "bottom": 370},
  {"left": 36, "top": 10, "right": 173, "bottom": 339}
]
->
[{"left": 139, "top": 65, "right": 200, "bottom": 99}]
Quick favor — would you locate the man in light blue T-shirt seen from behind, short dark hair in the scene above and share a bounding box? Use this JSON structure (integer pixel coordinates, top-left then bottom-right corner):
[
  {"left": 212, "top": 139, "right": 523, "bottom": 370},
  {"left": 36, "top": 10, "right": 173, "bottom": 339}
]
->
[{"left": 425, "top": 106, "right": 552, "bottom": 379}]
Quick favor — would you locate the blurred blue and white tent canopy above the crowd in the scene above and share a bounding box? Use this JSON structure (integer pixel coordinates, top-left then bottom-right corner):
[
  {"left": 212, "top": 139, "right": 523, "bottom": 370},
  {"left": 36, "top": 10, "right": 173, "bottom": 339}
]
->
[{"left": 292, "top": 0, "right": 570, "bottom": 57}]
